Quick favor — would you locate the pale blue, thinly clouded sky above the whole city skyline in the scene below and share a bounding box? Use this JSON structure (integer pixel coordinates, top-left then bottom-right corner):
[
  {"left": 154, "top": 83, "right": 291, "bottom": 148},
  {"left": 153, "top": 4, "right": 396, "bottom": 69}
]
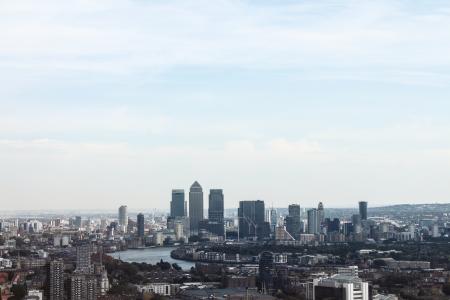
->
[{"left": 0, "top": 0, "right": 450, "bottom": 210}]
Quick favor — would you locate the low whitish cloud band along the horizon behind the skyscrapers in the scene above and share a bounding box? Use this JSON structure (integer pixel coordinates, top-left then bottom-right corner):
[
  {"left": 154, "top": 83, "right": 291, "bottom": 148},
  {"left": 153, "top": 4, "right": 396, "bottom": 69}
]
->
[{"left": 0, "top": 139, "right": 450, "bottom": 209}]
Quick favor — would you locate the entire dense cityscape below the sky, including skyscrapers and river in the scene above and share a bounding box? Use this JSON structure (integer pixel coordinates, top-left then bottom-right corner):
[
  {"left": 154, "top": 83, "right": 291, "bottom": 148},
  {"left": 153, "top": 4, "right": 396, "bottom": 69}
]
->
[{"left": 0, "top": 182, "right": 450, "bottom": 300}]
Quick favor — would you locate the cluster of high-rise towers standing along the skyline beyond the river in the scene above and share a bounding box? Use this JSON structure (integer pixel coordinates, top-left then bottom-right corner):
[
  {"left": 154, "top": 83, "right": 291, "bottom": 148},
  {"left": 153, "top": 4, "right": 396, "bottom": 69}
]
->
[{"left": 116, "top": 181, "right": 367, "bottom": 244}]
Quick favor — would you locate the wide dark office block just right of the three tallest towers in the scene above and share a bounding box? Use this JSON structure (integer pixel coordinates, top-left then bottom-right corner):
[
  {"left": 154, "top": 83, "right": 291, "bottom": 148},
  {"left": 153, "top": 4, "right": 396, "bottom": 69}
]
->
[{"left": 238, "top": 200, "right": 270, "bottom": 238}]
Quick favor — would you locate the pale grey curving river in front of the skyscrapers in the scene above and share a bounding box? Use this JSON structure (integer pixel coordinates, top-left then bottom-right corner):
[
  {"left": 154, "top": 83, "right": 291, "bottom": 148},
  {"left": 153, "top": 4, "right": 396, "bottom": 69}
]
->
[{"left": 108, "top": 247, "right": 195, "bottom": 270}]
